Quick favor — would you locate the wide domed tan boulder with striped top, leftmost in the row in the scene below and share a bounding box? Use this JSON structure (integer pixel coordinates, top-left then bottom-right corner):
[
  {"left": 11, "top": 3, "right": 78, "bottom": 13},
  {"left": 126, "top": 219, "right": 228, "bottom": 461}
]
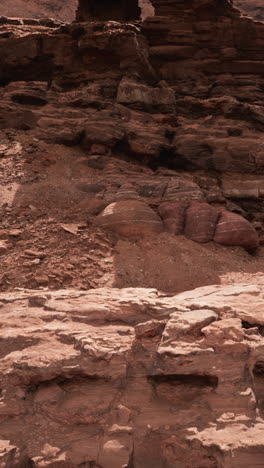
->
[{"left": 95, "top": 200, "right": 163, "bottom": 237}]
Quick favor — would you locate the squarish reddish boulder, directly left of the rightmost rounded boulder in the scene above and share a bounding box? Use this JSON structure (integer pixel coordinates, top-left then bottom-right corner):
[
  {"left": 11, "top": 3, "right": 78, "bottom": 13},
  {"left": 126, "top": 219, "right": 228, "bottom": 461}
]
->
[{"left": 184, "top": 202, "right": 219, "bottom": 242}]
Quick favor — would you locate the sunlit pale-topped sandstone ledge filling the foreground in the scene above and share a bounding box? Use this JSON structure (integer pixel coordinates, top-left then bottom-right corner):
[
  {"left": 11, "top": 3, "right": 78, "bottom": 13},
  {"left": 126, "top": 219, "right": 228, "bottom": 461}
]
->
[{"left": 0, "top": 285, "right": 264, "bottom": 468}]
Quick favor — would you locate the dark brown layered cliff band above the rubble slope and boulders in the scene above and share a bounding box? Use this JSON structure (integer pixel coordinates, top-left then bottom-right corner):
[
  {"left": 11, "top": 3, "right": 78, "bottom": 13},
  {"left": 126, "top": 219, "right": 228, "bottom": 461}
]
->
[{"left": 0, "top": 0, "right": 264, "bottom": 245}]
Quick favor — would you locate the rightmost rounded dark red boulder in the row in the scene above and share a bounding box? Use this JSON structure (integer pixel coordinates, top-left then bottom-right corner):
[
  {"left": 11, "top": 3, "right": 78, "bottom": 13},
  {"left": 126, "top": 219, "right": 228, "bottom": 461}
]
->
[{"left": 214, "top": 211, "right": 258, "bottom": 250}]
